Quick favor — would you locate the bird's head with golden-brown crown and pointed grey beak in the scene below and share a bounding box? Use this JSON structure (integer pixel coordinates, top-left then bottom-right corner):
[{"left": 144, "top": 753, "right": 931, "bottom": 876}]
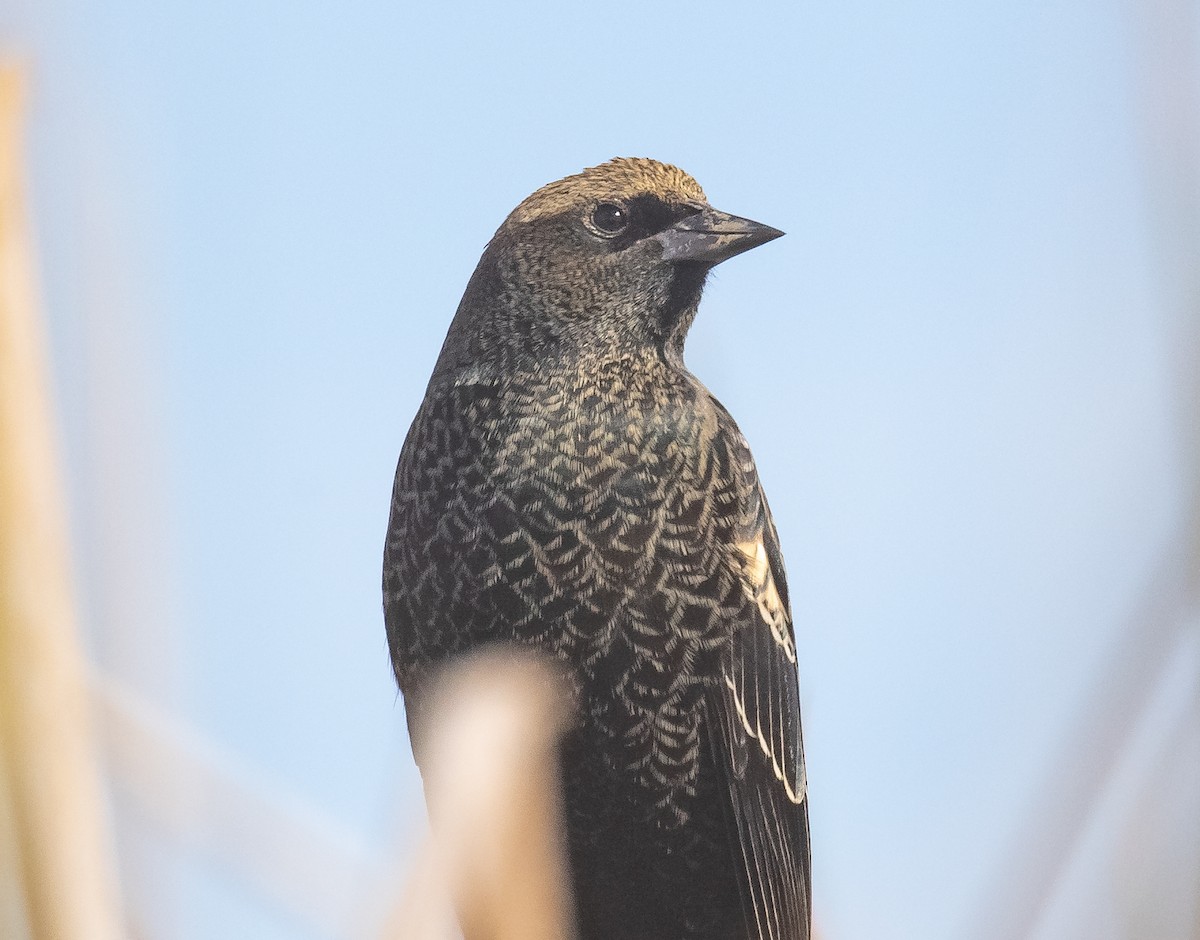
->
[{"left": 436, "top": 163, "right": 784, "bottom": 379}]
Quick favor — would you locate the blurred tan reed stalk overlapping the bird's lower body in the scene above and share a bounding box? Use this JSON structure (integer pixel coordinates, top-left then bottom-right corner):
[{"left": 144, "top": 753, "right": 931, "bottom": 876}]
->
[{"left": 384, "top": 648, "right": 575, "bottom": 940}]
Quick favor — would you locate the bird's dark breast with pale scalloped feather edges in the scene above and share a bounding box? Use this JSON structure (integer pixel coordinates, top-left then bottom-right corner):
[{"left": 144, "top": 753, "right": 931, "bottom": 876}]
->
[{"left": 391, "top": 372, "right": 745, "bottom": 813}]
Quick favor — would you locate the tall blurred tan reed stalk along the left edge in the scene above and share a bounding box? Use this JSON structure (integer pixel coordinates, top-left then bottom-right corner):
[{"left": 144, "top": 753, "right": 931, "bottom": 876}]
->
[{"left": 0, "top": 66, "right": 124, "bottom": 940}]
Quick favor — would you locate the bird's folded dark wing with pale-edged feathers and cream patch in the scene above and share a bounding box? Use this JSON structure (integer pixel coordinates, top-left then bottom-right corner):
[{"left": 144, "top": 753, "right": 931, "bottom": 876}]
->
[{"left": 708, "top": 450, "right": 811, "bottom": 940}]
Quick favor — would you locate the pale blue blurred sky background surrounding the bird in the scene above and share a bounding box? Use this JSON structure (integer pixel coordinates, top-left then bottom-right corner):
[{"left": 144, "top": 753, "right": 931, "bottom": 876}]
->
[{"left": 0, "top": 0, "right": 1200, "bottom": 940}]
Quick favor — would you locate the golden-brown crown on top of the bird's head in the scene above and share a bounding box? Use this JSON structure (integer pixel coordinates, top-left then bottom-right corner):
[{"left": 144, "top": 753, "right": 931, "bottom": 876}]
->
[{"left": 508, "top": 157, "right": 706, "bottom": 224}]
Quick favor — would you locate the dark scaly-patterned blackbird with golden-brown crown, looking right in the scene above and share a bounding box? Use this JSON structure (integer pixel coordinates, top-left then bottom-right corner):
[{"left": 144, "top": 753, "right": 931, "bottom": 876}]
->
[{"left": 383, "top": 157, "right": 811, "bottom": 940}]
